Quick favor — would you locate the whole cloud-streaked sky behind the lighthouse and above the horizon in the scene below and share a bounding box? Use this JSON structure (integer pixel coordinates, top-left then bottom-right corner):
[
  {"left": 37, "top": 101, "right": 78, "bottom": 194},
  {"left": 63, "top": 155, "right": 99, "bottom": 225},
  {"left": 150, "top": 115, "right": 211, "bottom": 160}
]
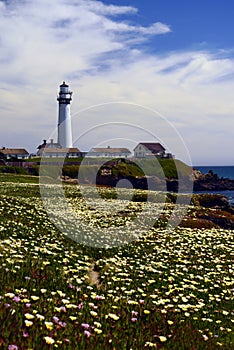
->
[{"left": 0, "top": 0, "right": 234, "bottom": 165}]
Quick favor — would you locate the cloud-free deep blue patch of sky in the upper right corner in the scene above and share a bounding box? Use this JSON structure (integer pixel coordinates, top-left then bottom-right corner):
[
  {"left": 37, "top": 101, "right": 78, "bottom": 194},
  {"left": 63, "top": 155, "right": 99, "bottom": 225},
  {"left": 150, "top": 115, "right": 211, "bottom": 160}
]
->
[{"left": 104, "top": 0, "right": 234, "bottom": 52}]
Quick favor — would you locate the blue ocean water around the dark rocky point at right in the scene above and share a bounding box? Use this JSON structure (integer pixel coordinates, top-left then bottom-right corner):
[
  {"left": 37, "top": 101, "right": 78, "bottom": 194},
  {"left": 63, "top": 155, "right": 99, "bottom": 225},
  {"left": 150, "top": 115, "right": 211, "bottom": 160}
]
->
[{"left": 194, "top": 166, "right": 234, "bottom": 205}]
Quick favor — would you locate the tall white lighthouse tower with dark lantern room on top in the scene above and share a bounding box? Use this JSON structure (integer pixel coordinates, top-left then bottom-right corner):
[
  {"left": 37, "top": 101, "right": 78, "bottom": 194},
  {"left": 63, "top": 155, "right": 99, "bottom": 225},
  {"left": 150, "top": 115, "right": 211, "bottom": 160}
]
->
[{"left": 57, "top": 81, "right": 72, "bottom": 148}]
